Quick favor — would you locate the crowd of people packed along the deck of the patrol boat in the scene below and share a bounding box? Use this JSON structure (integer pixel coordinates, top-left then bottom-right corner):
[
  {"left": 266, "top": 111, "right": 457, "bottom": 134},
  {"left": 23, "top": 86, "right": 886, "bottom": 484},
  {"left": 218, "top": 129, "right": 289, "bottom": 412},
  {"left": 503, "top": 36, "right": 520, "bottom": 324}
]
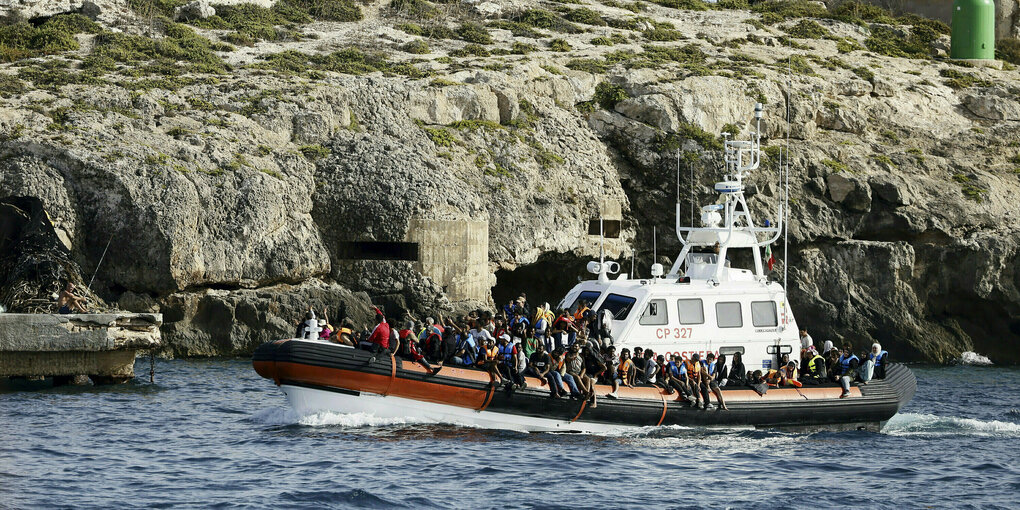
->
[{"left": 296, "top": 294, "right": 888, "bottom": 410}]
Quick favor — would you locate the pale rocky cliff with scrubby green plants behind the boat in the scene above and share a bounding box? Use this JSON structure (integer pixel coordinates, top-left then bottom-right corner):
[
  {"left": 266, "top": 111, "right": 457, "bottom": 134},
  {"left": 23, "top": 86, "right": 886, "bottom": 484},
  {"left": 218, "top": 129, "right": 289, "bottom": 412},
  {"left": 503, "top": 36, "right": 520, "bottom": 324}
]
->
[{"left": 0, "top": 0, "right": 1020, "bottom": 361}]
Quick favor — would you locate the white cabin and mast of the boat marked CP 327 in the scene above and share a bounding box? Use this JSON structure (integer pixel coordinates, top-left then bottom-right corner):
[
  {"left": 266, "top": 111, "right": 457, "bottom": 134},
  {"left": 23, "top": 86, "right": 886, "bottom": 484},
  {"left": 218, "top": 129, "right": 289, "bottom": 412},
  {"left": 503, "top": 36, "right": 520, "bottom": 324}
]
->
[{"left": 559, "top": 104, "right": 801, "bottom": 369}]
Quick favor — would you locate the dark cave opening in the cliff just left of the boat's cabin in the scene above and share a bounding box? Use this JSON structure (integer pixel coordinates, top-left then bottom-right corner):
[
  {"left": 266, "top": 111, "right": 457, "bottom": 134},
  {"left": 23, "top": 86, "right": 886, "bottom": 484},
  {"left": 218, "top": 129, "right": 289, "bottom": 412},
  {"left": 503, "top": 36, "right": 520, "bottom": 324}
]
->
[{"left": 493, "top": 253, "right": 594, "bottom": 311}]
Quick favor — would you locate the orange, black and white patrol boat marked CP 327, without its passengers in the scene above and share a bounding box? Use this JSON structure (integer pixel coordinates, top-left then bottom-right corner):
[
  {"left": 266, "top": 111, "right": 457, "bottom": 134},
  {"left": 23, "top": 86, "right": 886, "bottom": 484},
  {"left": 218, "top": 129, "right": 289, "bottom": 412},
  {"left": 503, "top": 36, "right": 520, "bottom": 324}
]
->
[{"left": 252, "top": 104, "right": 917, "bottom": 432}]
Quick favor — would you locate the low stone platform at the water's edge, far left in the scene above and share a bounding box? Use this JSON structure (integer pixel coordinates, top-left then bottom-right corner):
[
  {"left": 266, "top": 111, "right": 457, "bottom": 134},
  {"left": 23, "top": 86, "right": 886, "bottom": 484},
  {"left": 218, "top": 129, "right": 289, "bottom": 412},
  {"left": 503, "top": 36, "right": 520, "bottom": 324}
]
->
[{"left": 0, "top": 313, "right": 163, "bottom": 385}]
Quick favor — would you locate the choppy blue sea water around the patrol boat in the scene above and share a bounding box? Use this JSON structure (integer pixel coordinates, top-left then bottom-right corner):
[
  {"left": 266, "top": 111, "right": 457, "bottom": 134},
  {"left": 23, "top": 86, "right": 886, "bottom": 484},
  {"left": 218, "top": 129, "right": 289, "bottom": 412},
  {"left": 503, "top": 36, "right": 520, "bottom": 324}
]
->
[{"left": 0, "top": 359, "right": 1020, "bottom": 509}]
